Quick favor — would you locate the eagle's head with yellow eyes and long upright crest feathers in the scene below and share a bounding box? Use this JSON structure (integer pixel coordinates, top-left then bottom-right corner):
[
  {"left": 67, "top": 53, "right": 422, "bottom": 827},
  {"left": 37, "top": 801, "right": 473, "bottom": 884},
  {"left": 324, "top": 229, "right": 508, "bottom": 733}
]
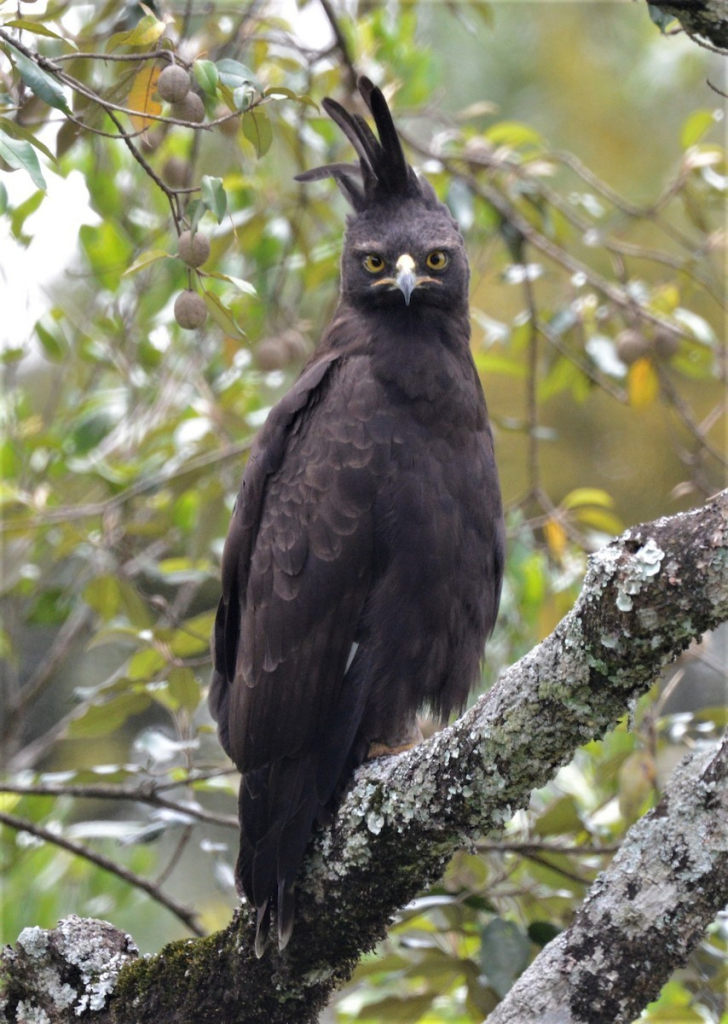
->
[{"left": 297, "top": 77, "right": 469, "bottom": 312}]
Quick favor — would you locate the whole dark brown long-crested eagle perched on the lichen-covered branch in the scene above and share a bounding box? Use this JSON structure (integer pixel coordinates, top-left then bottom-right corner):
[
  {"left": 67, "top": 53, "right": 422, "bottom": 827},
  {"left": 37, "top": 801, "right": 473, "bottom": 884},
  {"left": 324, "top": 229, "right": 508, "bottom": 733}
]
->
[{"left": 210, "top": 78, "right": 504, "bottom": 955}]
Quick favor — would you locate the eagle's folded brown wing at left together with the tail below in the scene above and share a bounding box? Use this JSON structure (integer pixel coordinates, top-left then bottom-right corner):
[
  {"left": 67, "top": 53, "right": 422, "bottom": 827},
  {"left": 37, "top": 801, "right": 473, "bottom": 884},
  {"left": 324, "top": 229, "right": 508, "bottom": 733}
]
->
[{"left": 211, "top": 352, "right": 388, "bottom": 946}]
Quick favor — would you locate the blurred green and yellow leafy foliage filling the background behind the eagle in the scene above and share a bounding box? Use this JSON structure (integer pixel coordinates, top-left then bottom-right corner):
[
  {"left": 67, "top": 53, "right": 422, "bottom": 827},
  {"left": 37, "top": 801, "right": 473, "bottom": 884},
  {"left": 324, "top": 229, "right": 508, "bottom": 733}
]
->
[{"left": 0, "top": 0, "right": 727, "bottom": 1022}]
